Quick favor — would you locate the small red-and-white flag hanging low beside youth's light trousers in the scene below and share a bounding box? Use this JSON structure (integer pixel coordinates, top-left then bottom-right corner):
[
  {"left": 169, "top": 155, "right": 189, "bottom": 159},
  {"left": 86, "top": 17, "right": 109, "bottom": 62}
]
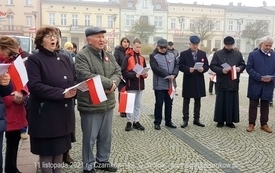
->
[{"left": 118, "top": 92, "right": 136, "bottom": 113}]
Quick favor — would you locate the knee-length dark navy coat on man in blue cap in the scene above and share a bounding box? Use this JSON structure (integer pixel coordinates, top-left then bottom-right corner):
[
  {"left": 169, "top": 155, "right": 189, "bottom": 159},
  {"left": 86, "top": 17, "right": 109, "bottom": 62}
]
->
[{"left": 179, "top": 49, "right": 209, "bottom": 98}]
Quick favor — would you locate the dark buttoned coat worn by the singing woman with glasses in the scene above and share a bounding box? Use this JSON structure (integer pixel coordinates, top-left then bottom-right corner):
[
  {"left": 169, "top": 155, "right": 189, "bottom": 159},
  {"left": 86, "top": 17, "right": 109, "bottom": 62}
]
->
[{"left": 26, "top": 48, "right": 76, "bottom": 138}]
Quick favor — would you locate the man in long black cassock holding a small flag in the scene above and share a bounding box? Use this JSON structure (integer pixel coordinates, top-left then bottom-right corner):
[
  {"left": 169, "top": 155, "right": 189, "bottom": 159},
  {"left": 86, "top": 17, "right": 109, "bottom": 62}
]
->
[{"left": 210, "top": 36, "right": 246, "bottom": 128}]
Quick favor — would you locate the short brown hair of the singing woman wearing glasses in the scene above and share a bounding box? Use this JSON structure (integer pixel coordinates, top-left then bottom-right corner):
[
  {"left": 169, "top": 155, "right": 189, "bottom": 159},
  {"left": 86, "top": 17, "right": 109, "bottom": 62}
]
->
[{"left": 34, "top": 26, "right": 59, "bottom": 49}]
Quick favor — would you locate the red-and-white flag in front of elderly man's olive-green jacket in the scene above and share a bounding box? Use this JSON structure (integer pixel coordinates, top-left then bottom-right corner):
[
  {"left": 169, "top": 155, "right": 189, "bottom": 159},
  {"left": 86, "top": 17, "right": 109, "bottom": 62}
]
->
[{"left": 86, "top": 75, "right": 107, "bottom": 105}]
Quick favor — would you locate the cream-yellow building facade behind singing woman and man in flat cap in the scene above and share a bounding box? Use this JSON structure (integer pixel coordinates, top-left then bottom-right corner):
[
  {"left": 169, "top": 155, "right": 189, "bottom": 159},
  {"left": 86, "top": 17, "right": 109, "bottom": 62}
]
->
[{"left": 41, "top": 0, "right": 120, "bottom": 49}]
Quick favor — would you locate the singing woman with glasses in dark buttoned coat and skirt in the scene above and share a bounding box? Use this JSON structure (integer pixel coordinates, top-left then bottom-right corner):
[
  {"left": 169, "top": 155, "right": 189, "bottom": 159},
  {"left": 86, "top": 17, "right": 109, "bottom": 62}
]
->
[{"left": 26, "top": 27, "right": 76, "bottom": 173}]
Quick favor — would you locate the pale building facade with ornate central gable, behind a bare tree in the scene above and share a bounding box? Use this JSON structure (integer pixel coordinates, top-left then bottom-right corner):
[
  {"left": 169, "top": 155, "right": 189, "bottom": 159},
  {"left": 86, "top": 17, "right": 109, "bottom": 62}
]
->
[{"left": 112, "top": 0, "right": 168, "bottom": 44}]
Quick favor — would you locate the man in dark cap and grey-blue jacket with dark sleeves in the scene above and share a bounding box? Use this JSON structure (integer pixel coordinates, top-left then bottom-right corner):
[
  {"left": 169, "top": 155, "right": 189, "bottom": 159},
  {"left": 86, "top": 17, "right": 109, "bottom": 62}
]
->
[{"left": 150, "top": 39, "right": 179, "bottom": 130}]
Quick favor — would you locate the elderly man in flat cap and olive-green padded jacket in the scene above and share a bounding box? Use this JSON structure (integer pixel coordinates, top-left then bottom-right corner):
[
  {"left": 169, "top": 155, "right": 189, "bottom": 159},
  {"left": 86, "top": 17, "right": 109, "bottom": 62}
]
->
[{"left": 75, "top": 27, "right": 121, "bottom": 173}]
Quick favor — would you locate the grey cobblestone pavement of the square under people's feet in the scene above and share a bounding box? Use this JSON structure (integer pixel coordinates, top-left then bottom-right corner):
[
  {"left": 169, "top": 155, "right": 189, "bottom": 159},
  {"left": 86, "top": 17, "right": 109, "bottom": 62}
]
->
[{"left": 34, "top": 69, "right": 275, "bottom": 173}]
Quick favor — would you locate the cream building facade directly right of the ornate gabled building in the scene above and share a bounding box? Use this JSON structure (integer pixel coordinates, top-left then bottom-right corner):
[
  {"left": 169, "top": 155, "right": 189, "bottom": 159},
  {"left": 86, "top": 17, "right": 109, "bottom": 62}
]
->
[{"left": 167, "top": 3, "right": 225, "bottom": 52}]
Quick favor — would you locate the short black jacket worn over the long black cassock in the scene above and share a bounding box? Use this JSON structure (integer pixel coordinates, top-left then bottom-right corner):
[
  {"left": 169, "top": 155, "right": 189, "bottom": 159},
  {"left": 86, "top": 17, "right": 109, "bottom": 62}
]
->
[{"left": 210, "top": 48, "right": 246, "bottom": 91}]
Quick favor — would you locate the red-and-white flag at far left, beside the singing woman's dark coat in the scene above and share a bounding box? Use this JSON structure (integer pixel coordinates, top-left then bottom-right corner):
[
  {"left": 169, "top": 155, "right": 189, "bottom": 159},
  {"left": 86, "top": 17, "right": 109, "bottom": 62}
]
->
[{"left": 8, "top": 56, "right": 29, "bottom": 91}]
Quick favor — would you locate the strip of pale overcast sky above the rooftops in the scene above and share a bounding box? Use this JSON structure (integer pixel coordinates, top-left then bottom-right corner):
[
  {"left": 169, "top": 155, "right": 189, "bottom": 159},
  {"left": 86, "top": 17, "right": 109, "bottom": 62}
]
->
[{"left": 83, "top": 0, "right": 275, "bottom": 6}]
